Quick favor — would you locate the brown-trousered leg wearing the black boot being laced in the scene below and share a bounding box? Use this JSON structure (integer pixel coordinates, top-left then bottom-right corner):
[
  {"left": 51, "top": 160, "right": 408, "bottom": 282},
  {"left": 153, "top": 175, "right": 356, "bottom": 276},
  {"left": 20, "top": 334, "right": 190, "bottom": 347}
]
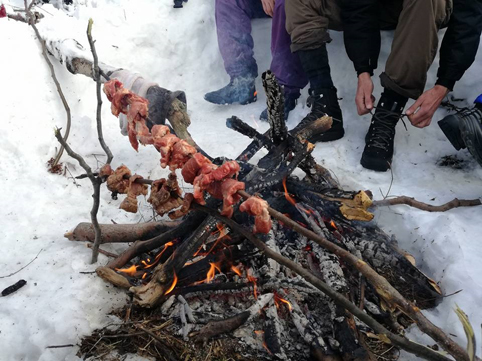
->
[{"left": 361, "top": 0, "right": 451, "bottom": 172}]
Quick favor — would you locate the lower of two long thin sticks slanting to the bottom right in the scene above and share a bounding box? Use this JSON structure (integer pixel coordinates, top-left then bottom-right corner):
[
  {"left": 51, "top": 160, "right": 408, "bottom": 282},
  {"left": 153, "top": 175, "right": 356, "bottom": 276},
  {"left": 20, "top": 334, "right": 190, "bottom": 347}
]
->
[{"left": 194, "top": 204, "right": 452, "bottom": 361}]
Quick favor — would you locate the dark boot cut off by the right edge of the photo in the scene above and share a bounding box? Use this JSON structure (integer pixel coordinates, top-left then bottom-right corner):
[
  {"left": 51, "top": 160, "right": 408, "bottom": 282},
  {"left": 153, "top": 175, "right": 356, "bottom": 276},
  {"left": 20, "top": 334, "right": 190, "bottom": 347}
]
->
[{"left": 438, "top": 104, "right": 482, "bottom": 166}]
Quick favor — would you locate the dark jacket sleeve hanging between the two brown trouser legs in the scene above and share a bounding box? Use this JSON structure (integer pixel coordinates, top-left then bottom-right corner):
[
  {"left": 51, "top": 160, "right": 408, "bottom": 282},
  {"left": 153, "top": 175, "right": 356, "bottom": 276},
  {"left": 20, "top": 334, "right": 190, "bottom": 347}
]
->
[{"left": 341, "top": 0, "right": 380, "bottom": 75}]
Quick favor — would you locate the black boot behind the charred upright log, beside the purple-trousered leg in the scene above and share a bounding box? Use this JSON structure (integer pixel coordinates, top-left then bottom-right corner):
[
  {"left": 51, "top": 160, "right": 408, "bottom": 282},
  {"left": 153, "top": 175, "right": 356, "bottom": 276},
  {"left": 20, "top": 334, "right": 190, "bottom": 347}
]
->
[{"left": 292, "top": 87, "right": 345, "bottom": 143}]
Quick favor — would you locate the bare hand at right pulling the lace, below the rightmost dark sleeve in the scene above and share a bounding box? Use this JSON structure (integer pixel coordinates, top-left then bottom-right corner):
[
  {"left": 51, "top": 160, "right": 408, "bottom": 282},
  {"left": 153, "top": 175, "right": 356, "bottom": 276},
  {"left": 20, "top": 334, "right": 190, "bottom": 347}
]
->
[{"left": 407, "top": 85, "right": 449, "bottom": 128}]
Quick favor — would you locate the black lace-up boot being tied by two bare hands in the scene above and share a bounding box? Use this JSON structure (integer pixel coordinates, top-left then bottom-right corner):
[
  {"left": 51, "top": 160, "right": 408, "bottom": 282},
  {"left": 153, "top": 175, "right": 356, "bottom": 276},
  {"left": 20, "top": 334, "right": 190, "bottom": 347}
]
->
[{"left": 360, "top": 90, "right": 408, "bottom": 172}]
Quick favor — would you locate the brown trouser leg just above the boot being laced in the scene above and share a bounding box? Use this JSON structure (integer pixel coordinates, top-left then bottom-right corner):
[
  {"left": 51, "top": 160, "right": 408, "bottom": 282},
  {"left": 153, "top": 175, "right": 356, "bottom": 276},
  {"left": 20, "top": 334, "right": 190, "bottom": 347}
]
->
[{"left": 380, "top": 0, "right": 451, "bottom": 99}]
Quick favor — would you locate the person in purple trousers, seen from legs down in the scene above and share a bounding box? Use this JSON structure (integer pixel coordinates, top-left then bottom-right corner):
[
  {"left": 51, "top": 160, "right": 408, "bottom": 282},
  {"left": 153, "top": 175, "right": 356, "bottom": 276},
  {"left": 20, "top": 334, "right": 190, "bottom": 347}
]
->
[{"left": 204, "top": 0, "right": 308, "bottom": 120}]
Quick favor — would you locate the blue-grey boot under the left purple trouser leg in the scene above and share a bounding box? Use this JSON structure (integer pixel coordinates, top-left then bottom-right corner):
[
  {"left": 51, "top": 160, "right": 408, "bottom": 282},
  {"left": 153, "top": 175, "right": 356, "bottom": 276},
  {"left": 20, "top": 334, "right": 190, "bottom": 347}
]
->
[{"left": 204, "top": 78, "right": 257, "bottom": 105}]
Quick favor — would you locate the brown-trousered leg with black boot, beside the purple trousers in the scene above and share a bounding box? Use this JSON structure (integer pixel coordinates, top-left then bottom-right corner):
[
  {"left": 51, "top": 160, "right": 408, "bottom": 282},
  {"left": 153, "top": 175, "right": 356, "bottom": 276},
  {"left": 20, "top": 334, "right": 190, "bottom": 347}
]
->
[{"left": 286, "top": 0, "right": 344, "bottom": 142}]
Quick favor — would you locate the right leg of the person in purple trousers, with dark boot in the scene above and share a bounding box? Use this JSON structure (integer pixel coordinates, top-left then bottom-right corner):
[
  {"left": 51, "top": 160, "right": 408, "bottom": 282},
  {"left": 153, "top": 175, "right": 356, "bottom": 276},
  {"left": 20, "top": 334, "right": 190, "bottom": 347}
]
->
[{"left": 260, "top": 0, "right": 308, "bottom": 120}]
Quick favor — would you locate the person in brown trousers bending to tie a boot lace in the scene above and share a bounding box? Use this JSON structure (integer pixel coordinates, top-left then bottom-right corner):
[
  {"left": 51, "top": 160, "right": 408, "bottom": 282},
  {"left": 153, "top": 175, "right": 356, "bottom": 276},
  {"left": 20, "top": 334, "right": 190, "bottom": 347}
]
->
[{"left": 286, "top": 0, "right": 482, "bottom": 171}]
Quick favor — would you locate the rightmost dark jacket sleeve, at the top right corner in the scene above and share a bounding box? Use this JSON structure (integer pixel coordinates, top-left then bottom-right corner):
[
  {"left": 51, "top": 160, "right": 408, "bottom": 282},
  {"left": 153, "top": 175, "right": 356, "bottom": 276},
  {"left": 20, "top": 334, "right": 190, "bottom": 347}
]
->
[{"left": 437, "top": 0, "right": 482, "bottom": 90}]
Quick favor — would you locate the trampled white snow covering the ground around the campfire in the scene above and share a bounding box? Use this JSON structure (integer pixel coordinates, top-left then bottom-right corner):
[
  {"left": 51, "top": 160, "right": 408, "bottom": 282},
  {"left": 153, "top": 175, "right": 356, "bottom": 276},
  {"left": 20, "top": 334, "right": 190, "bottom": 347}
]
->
[{"left": 0, "top": 0, "right": 482, "bottom": 361}]
